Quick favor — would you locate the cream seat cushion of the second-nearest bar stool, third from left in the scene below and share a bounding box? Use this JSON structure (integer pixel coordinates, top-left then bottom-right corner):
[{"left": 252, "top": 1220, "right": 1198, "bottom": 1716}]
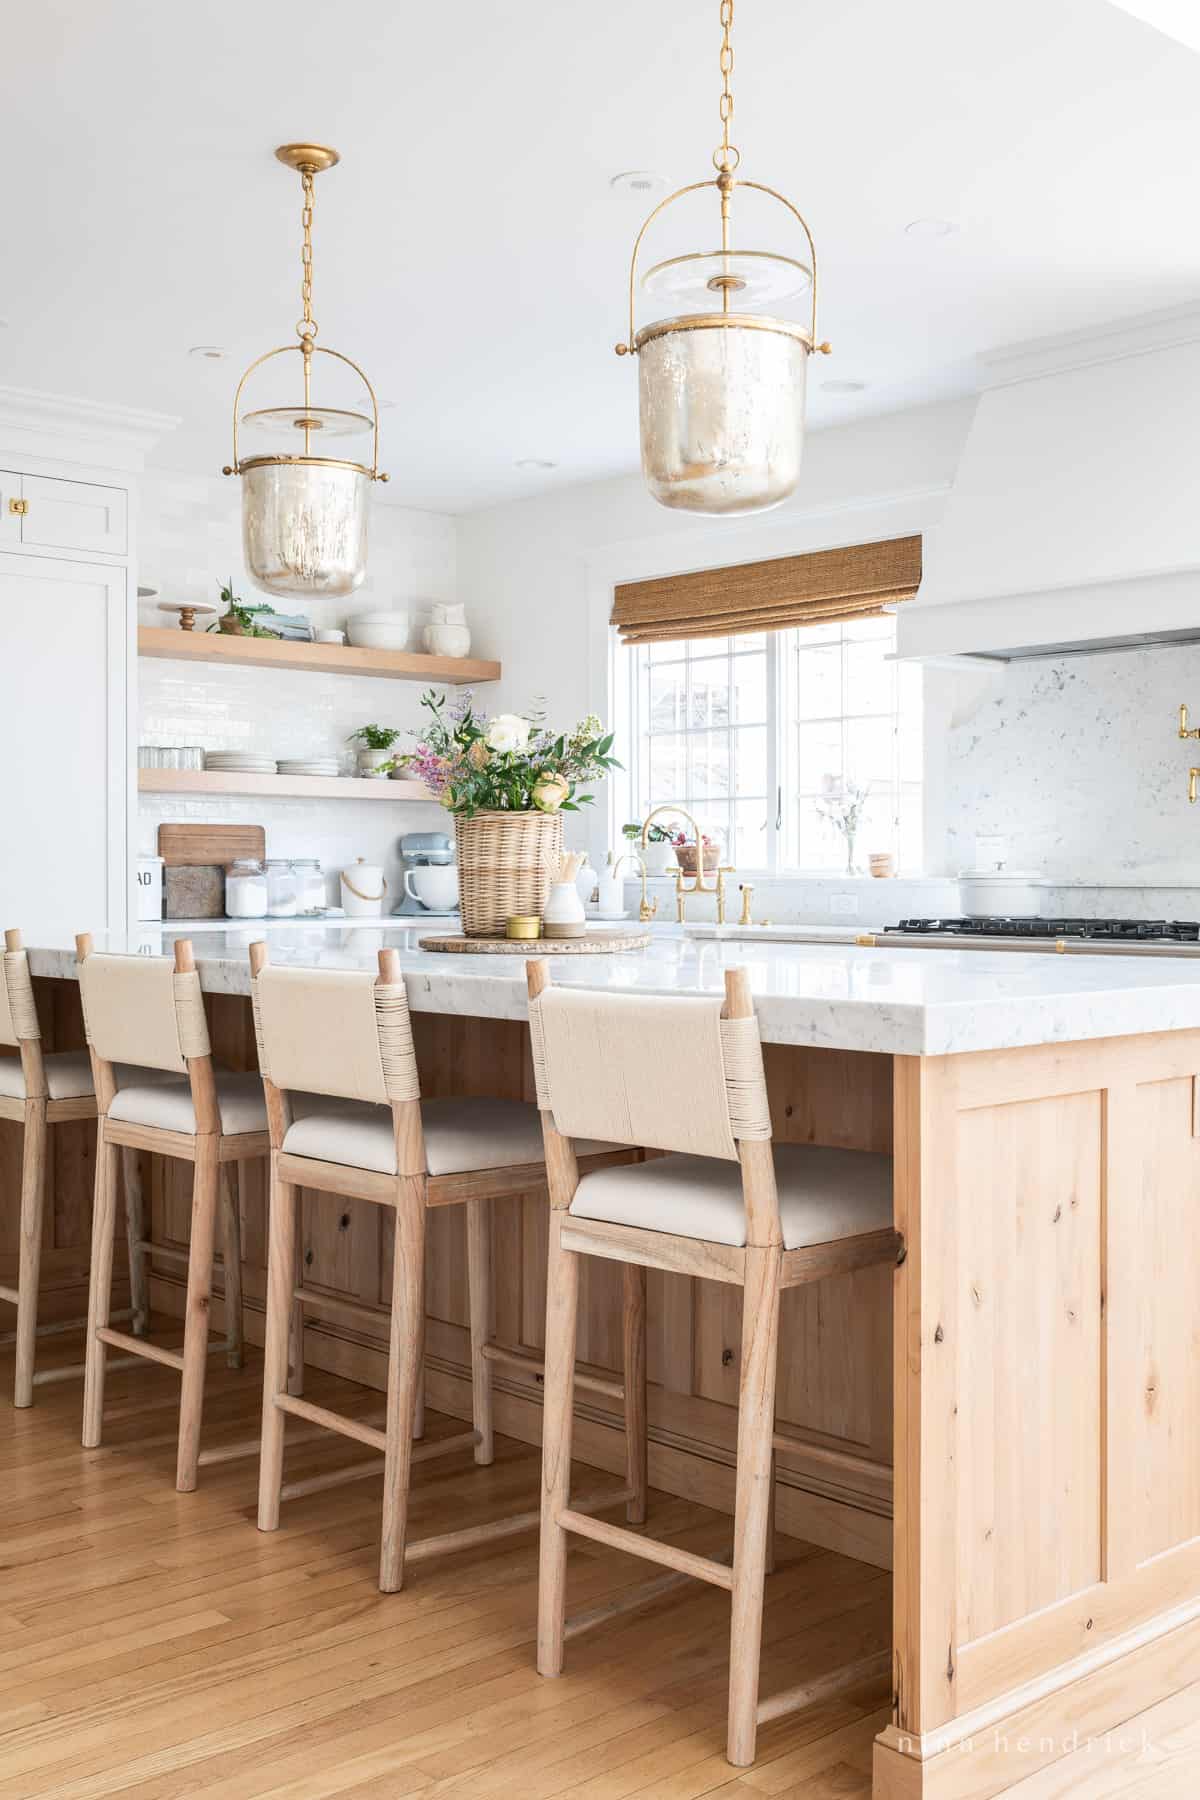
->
[{"left": 282, "top": 1096, "right": 613, "bottom": 1175}]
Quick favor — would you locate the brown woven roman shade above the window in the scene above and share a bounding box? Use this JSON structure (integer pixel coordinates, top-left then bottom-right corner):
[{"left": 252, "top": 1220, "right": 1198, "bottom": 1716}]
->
[{"left": 612, "top": 536, "right": 921, "bottom": 644}]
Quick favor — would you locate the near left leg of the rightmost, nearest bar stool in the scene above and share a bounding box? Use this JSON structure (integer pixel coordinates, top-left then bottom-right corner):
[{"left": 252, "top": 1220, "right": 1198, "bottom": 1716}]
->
[{"left": 538, "top": 1208, "right": 579, "bottom": 1676}]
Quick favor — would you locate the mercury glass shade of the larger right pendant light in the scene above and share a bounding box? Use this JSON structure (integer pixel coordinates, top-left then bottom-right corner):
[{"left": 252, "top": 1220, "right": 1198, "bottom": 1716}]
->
[{"left": 637, "top": 313, "right": 810, "bottom": 517}]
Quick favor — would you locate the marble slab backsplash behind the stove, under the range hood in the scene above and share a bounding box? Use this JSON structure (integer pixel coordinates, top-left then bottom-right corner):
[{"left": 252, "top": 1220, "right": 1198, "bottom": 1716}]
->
[{"left": 930, "top": 648, "right": 1200, "bottom": 885}]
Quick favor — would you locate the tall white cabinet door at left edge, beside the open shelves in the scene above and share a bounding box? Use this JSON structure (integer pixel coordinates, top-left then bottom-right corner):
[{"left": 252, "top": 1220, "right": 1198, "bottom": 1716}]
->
[{"left": 0, "top": 550, "right": 133, "bottom": 941}]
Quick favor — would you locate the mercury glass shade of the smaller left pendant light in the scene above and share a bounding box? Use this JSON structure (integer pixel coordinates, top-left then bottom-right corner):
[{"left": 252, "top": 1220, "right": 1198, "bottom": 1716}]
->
[{"left": 241, "top": 457, "right": 372, "bottom": 599}]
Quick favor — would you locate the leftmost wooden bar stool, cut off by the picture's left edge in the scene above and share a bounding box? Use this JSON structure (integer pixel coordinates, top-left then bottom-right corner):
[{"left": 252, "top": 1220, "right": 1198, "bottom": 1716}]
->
[{"left": 0, "top": 931, "right": 178, "bottom": 1406}]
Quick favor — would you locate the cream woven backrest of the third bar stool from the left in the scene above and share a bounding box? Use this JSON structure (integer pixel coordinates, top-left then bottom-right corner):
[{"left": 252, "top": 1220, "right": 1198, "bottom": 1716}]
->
[{"left": 252, "top": 952, "right": 421, "bottom": 1105}]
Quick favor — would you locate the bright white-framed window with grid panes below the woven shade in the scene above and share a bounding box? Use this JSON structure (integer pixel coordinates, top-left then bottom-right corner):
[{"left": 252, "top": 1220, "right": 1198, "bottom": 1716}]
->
[{"left": 615, "top": 616, "right": 921, "bottom": 875}]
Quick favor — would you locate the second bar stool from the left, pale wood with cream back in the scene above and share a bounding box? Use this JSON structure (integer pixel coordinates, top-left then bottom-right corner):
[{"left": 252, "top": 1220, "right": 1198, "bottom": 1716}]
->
[{"left": 76, "top": 934, "right": 268, "bottom": 1494}]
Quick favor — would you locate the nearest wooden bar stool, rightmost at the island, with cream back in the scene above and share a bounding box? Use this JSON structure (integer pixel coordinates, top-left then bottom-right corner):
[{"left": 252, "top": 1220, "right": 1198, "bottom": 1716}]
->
[{"left": 527, "top": 961, "right": 901, "bottom": 1768}]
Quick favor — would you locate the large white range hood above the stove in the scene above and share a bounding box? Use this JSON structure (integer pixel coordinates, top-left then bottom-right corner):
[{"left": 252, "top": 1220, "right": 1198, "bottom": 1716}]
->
[{"left": 898, "top": 308, "right": 1200, "bottom": 661}]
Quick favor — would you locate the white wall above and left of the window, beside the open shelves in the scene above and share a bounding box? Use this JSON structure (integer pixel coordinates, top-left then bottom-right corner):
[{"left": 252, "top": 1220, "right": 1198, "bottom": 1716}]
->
[{"left": 457, "top": 400, "right": 973, "bottom": 869}]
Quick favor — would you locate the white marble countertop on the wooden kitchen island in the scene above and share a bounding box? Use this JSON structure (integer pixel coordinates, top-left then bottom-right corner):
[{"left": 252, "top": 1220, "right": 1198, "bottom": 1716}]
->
[{"left": 25, "top": 923, "right": 1200, "bottom": 1057}]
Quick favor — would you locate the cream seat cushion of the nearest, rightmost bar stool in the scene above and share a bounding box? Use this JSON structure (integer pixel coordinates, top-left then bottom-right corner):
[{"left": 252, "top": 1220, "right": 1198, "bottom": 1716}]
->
[{"left": 570, "top": 1143, "right": 892, "bottom": 1249}]
